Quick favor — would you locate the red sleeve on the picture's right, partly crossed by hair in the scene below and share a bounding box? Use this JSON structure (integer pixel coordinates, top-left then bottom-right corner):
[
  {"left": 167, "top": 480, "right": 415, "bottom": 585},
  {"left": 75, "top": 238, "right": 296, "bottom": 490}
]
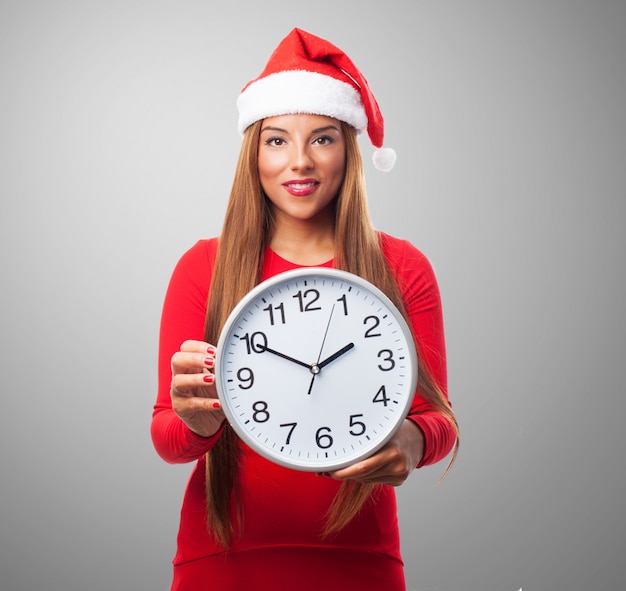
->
[{"left": 383, "top": 234, "right": 456, "bottom": 467}]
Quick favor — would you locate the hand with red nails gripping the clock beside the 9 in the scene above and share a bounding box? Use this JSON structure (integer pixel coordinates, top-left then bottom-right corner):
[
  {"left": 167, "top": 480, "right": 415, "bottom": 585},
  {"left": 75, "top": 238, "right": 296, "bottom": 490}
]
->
[{"left": 170, "top": 341, "right": 224, "bottom": 437}]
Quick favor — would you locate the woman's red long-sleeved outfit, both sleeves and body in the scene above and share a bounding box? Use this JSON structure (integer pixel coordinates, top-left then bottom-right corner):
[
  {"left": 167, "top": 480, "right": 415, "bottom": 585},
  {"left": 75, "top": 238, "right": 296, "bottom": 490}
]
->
[{"left": 151, "top": 234, "right": 455, "bottom": 591}]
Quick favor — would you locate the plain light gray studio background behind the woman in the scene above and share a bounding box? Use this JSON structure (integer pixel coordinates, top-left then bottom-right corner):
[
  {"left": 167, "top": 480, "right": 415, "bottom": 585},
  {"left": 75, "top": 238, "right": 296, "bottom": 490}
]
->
[{"left": 0, "top": 0, "right": 626, "bottom": 591}]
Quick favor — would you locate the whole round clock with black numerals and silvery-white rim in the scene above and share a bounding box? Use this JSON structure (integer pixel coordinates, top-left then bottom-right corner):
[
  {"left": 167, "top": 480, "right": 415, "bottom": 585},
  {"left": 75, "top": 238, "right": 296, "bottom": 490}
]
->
[{"left": 215, "top": 267, "right": 417, "bottom": 471}]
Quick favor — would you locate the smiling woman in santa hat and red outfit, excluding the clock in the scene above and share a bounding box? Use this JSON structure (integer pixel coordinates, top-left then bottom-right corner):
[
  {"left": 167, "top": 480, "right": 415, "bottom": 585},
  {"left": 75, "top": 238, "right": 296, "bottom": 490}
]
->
[{"left": 152, "top": 29, "right": 458, "bottom": 591}]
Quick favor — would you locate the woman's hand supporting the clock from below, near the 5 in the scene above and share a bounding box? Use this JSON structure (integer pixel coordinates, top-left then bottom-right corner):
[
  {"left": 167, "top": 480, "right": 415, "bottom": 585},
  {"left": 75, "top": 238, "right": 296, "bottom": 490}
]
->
[{"left": 328, "top": 419, "right": 424, "bottom": 486}]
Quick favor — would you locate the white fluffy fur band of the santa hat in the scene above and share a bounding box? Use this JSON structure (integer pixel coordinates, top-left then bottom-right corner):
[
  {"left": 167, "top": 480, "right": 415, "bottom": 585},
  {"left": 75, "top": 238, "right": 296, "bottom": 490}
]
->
[{"left": 237, "top": 70, "right": 367, "bottom": 134}]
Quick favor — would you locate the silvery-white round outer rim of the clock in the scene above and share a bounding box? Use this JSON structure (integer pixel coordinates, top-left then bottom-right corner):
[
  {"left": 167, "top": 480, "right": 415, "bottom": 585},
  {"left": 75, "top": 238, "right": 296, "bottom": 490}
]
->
[{"left": 215, "top": 267, "right": 419, "bottom": 472}]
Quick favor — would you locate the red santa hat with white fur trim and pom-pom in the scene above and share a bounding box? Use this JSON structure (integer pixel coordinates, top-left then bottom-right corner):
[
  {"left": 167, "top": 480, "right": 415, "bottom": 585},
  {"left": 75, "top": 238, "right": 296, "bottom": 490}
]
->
[{"left": 237, "top": 29, "right": 396, "bottom": 171}]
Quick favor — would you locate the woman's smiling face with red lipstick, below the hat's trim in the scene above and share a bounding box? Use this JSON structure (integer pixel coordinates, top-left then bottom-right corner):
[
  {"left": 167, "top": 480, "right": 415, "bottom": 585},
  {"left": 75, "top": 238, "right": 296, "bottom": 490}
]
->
[{"left": 259, "top": 115, "right": 346, "bottom": 227}]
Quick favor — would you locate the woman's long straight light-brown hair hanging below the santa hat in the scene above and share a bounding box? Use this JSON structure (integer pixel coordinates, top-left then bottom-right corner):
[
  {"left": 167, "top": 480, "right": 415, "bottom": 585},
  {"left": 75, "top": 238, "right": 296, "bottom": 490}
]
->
[{"left": 204, "top": 121, "right": 458, "bottom": 548}]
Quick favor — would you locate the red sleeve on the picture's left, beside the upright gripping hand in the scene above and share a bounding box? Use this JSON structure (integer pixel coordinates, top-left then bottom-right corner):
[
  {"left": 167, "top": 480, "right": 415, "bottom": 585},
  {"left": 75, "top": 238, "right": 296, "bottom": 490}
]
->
[{"left": 150, "top": 239, "right": 224, "bottom": 464}]
